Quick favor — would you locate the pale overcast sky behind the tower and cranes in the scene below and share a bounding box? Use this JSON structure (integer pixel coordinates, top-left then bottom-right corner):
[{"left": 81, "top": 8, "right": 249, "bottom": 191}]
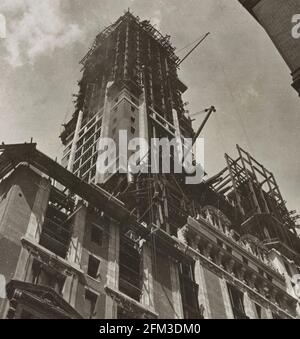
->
[{"left": 0, "top": 0, "right": 300, "bottom": 214}]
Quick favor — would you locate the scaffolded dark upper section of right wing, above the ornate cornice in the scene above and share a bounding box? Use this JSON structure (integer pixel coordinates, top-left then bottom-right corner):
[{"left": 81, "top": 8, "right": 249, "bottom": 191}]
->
[{"left": 212, "top": 145, "right": 300, "bottom": 261}]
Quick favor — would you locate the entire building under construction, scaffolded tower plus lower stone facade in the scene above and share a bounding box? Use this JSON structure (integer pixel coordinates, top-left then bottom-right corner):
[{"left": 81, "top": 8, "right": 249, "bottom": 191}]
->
[{"left": 0, "top": 12, "right": 300, "bottom": 319}]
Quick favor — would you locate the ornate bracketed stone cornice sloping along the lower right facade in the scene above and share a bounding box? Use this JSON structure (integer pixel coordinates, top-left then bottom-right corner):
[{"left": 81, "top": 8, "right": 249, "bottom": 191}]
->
[{"left": 173, "top": 219, "right": 296, "bottom": 318}]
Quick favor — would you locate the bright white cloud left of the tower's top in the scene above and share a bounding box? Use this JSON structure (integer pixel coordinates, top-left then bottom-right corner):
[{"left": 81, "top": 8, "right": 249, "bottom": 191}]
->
[{"left": 0, "top": 0, "right": 83, "bottom": 67}]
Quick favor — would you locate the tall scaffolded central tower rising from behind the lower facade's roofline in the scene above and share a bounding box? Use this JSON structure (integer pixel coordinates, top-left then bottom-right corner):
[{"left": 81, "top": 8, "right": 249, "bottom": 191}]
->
[{"left": 61, "top": 12, "right": 194, "bottom": 233}]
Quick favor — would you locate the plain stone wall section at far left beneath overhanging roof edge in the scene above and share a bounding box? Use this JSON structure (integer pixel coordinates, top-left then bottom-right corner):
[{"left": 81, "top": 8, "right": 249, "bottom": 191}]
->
[{"left": 0, "top": 166, "right": 49, "bottom": 318}]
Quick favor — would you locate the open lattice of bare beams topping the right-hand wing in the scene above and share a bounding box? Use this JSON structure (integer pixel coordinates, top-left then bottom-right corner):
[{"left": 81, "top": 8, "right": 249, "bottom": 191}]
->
[{"left": 213, "top": 145, "right": 295, "bottom": 229}]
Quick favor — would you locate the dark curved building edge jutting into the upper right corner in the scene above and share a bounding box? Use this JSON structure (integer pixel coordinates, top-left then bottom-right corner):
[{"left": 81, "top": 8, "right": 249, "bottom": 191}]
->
[{"left": 239, "top": 0, "right": 300, "bottom": 95}]
